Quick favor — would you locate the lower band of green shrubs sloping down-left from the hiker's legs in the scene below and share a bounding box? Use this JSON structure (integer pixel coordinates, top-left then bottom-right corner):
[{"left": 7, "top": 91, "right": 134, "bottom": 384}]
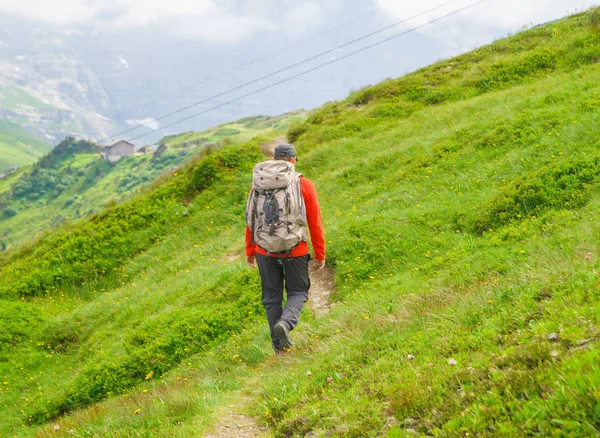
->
[{"left": 27, "top": 270, "right": 262, "bottom": 423}]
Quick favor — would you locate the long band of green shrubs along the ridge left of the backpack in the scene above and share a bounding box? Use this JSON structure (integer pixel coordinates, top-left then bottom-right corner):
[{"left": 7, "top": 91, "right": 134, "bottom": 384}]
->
[{"left": 0, "top": 144, "right": 262, "bottom": 297}]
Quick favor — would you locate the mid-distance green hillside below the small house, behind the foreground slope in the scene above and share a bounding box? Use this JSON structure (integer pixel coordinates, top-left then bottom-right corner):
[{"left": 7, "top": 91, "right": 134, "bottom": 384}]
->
[{"left": 0, "top": 111, "right": 305, "bottom": 249}]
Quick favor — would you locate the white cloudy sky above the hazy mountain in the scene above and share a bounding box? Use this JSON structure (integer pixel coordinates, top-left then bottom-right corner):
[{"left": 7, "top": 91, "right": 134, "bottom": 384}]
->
[{"left": 0, "top": 0, "right": 600, "bottom": 45}]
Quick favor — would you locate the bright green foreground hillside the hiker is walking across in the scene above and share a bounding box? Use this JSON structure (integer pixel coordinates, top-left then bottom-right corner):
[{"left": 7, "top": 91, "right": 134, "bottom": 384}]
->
[{"left": 0, "top": 7, "right": 600, "bottom": 437}]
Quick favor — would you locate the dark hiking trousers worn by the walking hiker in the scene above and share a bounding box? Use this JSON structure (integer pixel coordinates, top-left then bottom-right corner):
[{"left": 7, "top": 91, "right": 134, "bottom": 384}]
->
[{"left": 256, "top": 254, "right": 310, "bottom": 349}]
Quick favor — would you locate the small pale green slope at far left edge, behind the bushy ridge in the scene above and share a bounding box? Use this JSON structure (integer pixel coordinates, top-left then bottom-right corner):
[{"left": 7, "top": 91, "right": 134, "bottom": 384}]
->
[{"left": 0, "top": 120, "right": 52, "bottom": 173}]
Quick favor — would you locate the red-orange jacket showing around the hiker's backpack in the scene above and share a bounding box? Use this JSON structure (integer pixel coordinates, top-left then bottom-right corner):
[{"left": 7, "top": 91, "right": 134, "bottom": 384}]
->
[{"left": 246, "top": 176, "right": 325, "bottom": 260}]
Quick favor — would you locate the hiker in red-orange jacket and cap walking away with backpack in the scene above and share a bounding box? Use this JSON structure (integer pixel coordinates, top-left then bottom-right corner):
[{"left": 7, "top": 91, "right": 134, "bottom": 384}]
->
[{"left": 246, "top": 144, "right": 325, "bottom": 353}]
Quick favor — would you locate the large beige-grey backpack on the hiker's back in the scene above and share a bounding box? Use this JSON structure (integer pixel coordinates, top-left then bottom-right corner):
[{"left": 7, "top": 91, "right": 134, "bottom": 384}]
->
[{"left": 246, "top": 160, "right": 308, "bottom": 254}]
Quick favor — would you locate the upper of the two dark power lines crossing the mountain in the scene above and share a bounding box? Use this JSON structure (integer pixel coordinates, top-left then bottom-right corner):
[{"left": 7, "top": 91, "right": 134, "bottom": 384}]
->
[{"left": 98, "top": 0, "right": 458, "bottom": 143}]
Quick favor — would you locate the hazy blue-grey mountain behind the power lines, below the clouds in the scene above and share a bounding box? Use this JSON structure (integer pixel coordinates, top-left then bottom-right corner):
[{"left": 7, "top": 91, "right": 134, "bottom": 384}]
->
[{"left": 0, "top": 5, "right": 456, "bottom": 145}]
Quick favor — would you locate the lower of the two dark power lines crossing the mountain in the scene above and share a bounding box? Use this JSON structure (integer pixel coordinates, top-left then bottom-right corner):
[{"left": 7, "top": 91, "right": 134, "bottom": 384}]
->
[{"left": 129, "top": 0, "right": 488, "bottom": 142}]
